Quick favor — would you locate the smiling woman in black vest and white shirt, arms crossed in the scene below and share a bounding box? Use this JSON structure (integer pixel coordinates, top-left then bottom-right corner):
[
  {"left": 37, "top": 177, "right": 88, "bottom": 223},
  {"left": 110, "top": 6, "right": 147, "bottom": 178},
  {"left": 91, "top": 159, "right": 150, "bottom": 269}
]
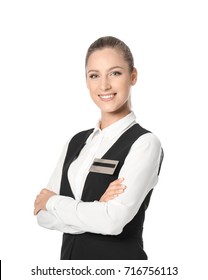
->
[{"left": 34, "top": 36, "right": 163, "bottom": 260}]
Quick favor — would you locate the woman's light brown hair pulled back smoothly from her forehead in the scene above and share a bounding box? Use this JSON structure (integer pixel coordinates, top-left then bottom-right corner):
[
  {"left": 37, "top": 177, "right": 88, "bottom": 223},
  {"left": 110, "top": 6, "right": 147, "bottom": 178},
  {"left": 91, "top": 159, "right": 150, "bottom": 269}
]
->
[{"left": 85, "top": 36, "right": 134, "bottom": 72}]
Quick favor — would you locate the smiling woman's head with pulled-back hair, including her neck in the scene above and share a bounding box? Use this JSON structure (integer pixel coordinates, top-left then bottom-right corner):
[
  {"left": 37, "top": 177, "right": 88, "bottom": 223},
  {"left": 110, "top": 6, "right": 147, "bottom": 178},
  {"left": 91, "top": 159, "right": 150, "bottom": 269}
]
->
[{"left": 85, "top": 37, "right": 137, "bottom": 128}]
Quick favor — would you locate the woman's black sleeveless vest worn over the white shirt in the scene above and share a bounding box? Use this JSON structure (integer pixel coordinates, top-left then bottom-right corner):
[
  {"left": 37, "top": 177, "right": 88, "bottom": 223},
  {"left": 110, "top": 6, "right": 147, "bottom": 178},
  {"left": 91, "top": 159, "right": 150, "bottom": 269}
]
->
[{"left": 60, "top": 124, "right": 152, "bottom": 260}]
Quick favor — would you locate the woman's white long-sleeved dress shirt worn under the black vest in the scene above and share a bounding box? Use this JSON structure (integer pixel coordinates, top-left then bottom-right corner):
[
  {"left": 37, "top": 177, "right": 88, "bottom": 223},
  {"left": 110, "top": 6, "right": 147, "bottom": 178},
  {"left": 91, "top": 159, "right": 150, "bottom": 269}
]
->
[{"left": 37, "top": 112, "right": 161, "bottom": 235}]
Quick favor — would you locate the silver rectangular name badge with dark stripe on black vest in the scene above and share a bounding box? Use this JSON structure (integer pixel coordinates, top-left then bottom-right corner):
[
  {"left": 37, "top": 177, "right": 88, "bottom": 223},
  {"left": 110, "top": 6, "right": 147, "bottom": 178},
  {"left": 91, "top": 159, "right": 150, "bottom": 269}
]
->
[{"left": 89, "top": 158, "right": 119, "bottom": 175}]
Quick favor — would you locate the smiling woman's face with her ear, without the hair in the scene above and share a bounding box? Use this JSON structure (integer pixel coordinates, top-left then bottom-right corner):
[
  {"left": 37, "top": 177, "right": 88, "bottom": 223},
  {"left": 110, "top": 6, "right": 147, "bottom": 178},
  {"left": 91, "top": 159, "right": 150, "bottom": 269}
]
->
[{"left": 86, "top": 48, "right": 137, "bottom": 117}]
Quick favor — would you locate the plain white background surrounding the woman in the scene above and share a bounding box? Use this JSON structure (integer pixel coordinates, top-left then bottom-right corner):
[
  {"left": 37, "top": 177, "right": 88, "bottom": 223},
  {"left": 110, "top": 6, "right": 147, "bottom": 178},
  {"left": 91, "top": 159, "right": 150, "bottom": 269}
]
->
[{"left": 0, "top": 0, "right": 208, "bottom": 280}]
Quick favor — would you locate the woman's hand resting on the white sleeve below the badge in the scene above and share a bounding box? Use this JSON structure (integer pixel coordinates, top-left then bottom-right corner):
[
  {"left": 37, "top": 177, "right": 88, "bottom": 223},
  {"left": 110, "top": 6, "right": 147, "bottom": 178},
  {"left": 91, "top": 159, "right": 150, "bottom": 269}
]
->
[{"left": 99, "top": 178, "right": 126, "bottom": 202}]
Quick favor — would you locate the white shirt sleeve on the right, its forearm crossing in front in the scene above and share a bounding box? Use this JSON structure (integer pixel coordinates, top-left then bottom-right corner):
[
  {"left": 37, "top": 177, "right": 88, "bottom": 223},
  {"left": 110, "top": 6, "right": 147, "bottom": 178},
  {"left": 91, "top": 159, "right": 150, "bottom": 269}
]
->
[{"left": 43, "top": 133, "right": 161, "bottom": 235}]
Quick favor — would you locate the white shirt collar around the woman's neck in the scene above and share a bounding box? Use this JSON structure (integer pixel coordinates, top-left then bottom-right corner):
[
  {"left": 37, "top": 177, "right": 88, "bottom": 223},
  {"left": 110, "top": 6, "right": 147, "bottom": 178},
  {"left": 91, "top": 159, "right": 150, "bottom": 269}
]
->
[{"left": 91, "top": 112, "right": 136, "bottom": 139}]
